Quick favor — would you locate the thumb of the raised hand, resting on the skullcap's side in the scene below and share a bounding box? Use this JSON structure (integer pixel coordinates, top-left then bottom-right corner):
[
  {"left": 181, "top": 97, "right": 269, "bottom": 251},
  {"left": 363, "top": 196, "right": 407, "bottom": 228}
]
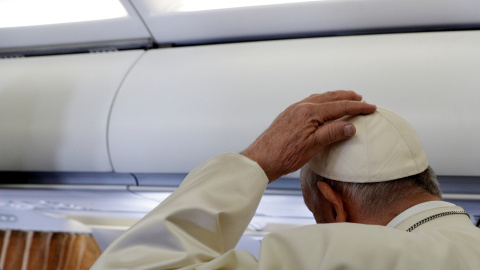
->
[{"left": 315, "top": 121, "right": 356, "bottom": 147}]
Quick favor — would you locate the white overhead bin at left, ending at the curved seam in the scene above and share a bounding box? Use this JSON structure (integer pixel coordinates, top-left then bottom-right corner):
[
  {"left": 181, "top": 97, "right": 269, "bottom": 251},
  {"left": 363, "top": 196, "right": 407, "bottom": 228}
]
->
[{"left": 0, "top": 50, "right": 144, "bottom": 172}]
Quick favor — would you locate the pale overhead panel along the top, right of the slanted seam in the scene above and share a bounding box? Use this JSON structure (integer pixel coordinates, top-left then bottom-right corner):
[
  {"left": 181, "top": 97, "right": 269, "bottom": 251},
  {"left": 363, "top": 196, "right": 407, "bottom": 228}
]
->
[{"left": 131, "top": 0, "right": 480, "bottom": 45}]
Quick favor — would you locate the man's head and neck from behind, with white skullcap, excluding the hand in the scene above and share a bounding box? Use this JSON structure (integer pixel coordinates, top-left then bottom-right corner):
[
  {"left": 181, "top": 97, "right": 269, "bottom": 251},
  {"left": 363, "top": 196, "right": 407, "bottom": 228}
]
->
[{"left": 300, "top": 107, "right": 446, "bottom": 227}]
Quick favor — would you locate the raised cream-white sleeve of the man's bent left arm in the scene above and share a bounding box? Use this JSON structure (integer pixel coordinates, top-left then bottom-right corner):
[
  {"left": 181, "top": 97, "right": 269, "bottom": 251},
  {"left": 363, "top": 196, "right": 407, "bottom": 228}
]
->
[{"left": 92, "top": 153, "right": 268, "bottom": 270}]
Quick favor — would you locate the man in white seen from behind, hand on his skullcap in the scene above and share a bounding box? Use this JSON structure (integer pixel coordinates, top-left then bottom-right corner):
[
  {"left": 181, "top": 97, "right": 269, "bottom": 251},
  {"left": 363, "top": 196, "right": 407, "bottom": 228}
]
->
[{"left": 92, "top": 91, "right": 480, "bottom": 270}]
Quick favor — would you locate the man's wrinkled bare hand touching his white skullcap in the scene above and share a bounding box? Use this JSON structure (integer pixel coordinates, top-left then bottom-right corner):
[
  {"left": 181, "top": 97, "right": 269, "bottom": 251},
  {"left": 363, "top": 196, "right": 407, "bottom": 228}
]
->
[{"left": 241, "top": 91, "right": 376, "bottom": 182}]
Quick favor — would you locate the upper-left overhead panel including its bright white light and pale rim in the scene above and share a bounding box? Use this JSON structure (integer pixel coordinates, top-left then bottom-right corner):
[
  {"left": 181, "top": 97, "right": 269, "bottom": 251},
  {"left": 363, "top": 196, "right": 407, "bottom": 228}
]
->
[{"left": 0, "top": 0, "right": 151, "bottom": 57}]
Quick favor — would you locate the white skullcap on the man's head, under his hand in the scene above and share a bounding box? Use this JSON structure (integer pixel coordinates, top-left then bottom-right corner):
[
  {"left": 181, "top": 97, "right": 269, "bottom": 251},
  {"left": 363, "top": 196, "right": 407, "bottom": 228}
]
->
[{"left": 308, "top": 106, "right": 428, "bottom": 183}]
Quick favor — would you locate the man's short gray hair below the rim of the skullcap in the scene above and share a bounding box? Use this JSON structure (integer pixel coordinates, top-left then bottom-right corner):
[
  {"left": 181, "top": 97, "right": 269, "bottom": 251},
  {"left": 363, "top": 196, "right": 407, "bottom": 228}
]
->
[{"left": 300, "top": 165, "right": 442, "bottom": 215}]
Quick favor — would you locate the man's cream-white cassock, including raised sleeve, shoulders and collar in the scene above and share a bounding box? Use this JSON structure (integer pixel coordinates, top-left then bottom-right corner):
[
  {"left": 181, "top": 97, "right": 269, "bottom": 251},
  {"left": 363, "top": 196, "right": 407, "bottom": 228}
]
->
[{"left": 92, "top": 153, "right": 480, "bottom": 270}]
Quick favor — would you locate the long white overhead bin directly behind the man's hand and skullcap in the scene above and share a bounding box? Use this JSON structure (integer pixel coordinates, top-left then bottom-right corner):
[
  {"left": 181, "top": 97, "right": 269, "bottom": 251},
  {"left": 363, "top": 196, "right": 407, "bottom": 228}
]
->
[{"left": 109, "top": 31, "right": 480, "bottom": 176}]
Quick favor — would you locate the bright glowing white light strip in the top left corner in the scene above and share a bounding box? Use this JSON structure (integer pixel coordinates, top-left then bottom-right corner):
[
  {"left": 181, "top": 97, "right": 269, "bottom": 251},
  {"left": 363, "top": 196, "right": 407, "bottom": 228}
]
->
[{"left": 0, "top": 0, "right": 128, "bottom": 28}]
